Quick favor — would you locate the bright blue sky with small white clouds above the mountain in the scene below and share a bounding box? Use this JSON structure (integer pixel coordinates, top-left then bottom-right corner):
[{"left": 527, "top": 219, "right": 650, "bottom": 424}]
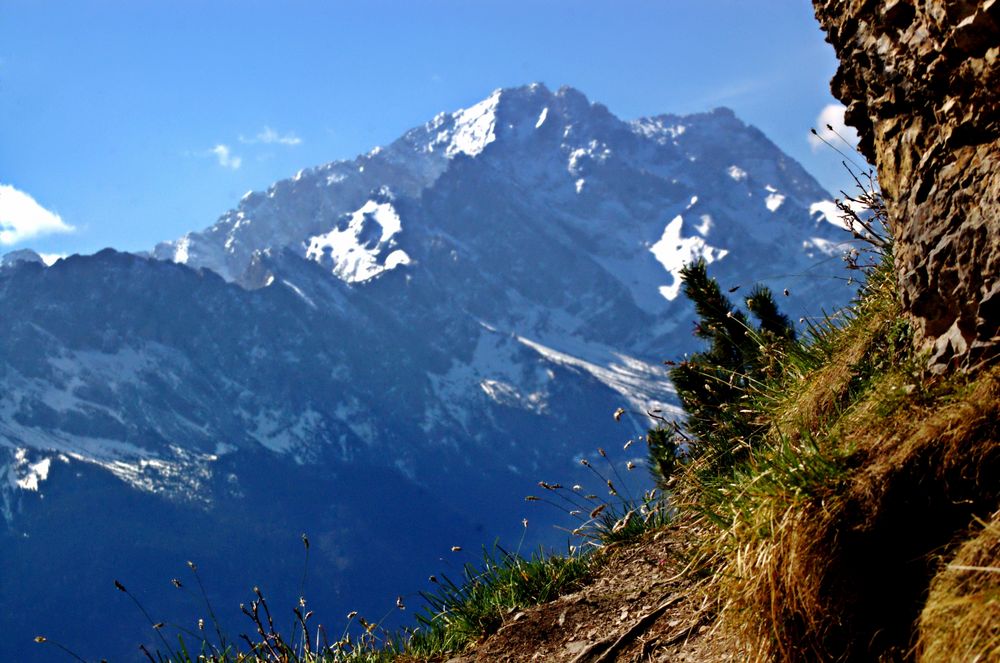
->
[{"left": 0, "top": 0, "right": 860, "bottom": 254}]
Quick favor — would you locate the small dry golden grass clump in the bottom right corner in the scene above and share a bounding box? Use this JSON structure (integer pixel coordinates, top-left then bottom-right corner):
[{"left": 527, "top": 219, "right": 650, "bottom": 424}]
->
[{"left": 918, "top": 512, "right": 1000, "bottom": 663}]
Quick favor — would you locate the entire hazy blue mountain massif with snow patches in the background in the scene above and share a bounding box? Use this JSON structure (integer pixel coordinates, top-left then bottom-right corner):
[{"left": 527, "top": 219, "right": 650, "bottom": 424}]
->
[{"left": 0, "top": 85, "right": 851, "bottom": 660}]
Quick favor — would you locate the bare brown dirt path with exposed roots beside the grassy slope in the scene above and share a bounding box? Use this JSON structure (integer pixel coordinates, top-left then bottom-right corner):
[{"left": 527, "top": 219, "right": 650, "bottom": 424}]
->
[{"left": 434, "top": 529, "right": 747, "bottom": 663}]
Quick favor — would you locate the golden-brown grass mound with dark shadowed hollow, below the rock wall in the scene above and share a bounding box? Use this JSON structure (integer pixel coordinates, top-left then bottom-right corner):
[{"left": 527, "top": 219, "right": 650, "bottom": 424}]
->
[{"left": 696, "top": 292, "right": 1000, "bottom": 661}]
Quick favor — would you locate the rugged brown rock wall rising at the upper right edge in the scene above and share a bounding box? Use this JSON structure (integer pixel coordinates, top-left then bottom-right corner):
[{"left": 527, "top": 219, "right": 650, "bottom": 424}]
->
[{"left": 814, "top": 0, "right": 1000, "bottom": 368}]
